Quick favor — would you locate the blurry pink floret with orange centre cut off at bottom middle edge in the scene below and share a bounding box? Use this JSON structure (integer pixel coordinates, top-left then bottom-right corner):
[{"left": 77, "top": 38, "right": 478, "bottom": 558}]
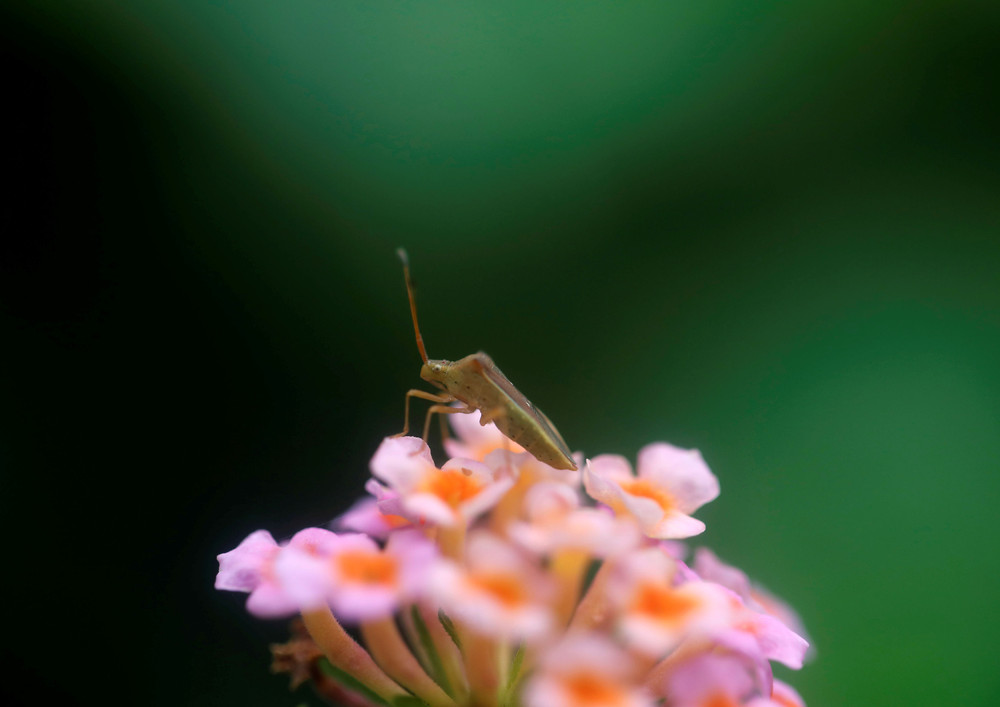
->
[{"left": 524, "top": 633, "right": 654, "bottom": 707}]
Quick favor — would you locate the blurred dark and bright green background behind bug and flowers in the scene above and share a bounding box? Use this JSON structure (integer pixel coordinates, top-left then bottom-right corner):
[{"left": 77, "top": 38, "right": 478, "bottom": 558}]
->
[{"left": 0, "top": 0, "right": 1000, "bottom": 707}]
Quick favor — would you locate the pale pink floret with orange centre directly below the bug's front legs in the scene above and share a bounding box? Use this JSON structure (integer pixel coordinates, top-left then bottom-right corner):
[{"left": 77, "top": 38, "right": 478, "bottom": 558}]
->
[{"left": 371, "top": 437, "right": 514, "bottom": 526}]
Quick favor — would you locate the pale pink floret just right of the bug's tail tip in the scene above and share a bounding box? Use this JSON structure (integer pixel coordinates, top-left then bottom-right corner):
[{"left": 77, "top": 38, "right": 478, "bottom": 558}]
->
[{"left": 583, "top": 442, "right": 719, "bottom": 539}]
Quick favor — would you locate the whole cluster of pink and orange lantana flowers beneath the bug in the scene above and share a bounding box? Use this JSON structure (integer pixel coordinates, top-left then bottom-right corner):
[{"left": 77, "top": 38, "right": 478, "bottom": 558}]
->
[{"left": 216, "top": 413, "right": 808, "bottom": 707}]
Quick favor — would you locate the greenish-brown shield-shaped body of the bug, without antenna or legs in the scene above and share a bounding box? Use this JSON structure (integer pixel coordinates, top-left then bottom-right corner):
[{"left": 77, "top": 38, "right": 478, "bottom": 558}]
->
[{"left": 420, "top": 351, "right": 576, "bottom": 470}]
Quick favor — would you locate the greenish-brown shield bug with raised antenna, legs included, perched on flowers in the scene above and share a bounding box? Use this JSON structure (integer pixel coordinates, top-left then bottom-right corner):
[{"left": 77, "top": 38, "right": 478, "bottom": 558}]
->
[{"left": 397, "top": 248, "right": 576, "bottom": 470}]
